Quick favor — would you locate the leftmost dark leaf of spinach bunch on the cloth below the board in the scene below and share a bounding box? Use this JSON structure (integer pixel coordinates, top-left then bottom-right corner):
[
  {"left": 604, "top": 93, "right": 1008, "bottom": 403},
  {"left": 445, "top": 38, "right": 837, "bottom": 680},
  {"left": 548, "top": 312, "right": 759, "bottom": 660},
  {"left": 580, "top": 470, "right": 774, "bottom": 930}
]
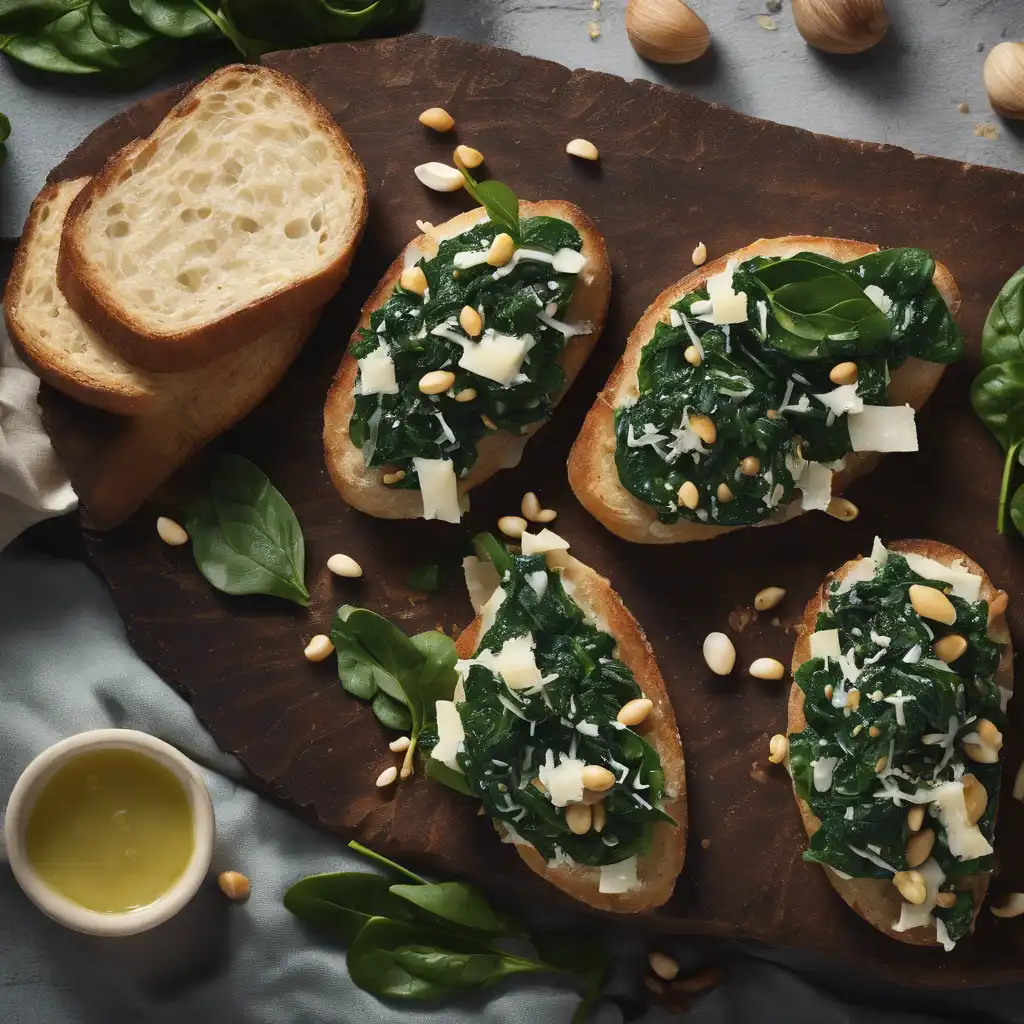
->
[{"left": 285, "top": 871, "right": 422, "bottom": 942}]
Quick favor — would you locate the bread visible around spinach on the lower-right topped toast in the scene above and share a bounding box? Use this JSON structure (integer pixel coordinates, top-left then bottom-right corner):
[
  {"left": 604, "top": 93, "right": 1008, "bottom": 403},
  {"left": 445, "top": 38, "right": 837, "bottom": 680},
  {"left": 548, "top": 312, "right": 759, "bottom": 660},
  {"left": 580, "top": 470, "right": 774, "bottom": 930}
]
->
[{"left": 787, "top": 541, "right": 1014, "bottom": 946}]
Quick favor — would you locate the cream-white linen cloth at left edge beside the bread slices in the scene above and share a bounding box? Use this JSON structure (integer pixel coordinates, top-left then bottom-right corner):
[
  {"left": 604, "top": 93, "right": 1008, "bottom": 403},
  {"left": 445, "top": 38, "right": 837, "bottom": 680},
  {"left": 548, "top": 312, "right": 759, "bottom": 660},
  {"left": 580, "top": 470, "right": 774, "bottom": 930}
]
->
[{"left": 0, "top": 318, "right": 78, "bottom": 551}]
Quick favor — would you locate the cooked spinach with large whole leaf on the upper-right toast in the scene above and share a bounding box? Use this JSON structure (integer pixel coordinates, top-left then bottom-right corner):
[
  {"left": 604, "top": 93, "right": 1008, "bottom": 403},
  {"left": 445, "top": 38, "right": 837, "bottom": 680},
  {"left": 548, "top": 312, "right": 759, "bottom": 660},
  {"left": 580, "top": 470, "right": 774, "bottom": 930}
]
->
[{"left": 615, "top": 249, "right": 964, "bottom": 526}]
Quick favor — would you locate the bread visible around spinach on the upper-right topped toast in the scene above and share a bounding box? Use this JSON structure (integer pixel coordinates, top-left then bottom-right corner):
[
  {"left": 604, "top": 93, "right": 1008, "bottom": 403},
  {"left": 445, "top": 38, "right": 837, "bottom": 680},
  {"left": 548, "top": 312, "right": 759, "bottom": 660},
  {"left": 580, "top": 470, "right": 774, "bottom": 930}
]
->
[{"left": 568, "top": 234, "right": 961, "bottom": 544}]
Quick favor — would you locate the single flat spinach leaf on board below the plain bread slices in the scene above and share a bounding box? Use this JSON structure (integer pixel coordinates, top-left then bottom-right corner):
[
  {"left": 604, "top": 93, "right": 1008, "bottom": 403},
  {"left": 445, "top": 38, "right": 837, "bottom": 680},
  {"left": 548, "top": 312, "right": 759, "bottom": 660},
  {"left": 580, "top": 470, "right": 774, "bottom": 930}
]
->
[{"left": 185, "top": 456, "right": 309, "bottom": 605}]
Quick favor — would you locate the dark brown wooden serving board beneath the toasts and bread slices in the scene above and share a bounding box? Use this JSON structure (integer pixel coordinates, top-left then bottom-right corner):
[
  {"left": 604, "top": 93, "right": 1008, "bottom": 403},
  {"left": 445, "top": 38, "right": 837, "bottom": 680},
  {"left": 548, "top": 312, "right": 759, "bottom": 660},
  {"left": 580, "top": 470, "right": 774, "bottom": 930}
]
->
[{"left": 34, "top": 36, "right": 1024, "bottom": 985}]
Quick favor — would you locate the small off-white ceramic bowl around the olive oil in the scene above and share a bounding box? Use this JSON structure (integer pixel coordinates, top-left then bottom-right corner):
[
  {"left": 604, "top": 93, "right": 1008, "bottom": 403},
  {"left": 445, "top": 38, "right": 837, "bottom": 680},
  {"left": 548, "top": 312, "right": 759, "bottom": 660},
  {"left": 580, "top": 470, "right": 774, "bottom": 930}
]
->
[{"left": 4, "top": 729, "right": 214, "bottom": 935}]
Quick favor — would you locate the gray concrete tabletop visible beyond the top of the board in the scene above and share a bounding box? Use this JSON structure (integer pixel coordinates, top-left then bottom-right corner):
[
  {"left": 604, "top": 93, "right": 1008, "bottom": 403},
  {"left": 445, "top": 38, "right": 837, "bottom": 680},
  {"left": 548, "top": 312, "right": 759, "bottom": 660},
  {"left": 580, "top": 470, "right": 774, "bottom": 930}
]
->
[{"left": 0, "top": 0, "right": 1024, "bottom": 238}]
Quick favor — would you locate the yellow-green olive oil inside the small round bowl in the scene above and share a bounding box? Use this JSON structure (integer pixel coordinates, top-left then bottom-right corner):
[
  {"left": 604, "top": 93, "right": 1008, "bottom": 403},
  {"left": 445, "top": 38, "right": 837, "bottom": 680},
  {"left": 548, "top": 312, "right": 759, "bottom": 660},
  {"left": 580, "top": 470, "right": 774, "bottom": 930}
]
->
[{"left": 26, "top": 749, "right": 195, "bottom": 913}]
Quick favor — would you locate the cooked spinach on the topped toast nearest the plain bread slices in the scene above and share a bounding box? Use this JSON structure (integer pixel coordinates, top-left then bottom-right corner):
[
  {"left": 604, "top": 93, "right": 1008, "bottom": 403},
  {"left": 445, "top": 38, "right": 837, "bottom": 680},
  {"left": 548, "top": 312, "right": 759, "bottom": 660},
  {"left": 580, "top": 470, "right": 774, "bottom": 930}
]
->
[{"left": 349, "top": 217, "right": 583, "bottom": 489}]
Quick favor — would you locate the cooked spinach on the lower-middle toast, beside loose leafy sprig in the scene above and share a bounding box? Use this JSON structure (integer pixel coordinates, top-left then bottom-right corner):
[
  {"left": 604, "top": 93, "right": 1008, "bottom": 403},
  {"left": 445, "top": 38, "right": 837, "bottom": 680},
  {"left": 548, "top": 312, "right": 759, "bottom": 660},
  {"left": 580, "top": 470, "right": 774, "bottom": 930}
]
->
[{"left": 440, "top": 544, "right": 674, "bottom": 865}]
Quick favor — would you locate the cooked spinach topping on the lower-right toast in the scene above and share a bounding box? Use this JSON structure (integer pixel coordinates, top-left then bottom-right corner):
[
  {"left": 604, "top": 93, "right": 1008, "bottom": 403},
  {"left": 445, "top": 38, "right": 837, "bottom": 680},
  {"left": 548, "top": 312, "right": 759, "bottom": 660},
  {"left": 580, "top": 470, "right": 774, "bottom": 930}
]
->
[{"left": 790, "top": 552, "right": 1006, "bottom": 940}]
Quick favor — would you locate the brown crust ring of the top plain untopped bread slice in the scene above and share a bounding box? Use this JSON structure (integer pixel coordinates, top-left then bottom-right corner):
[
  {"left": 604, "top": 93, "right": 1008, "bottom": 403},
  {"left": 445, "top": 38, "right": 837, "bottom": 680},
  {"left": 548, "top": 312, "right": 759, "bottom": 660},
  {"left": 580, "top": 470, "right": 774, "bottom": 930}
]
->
[{"left": 57, "top": 65, "right": 368, "bottom": 373}]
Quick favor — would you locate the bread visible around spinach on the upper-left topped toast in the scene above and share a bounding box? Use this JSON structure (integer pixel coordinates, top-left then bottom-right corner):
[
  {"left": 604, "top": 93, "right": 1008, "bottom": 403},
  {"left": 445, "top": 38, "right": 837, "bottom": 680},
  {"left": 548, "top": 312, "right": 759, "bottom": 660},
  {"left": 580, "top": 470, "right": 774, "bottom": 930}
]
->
[{"left": 324, "top": 200, "right": 611, "bottom": 519}]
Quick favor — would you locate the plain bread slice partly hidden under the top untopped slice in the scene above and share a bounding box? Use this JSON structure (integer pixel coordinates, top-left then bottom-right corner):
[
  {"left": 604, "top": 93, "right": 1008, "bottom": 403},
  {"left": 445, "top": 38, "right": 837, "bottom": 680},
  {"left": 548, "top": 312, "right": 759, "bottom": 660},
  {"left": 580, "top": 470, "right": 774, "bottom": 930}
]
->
[{"left": 3, "top": 178, "right": 163, "bottom": 416}]
